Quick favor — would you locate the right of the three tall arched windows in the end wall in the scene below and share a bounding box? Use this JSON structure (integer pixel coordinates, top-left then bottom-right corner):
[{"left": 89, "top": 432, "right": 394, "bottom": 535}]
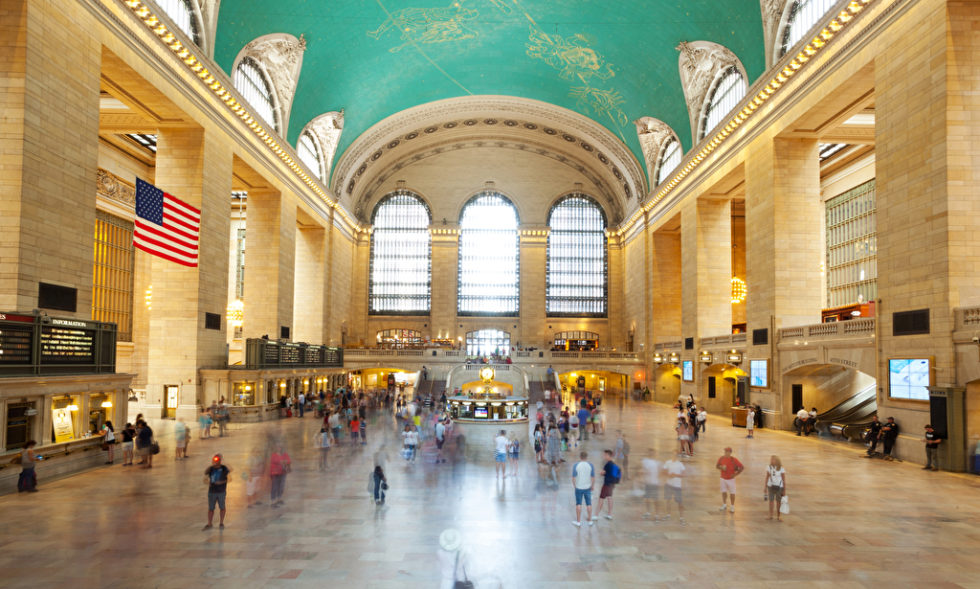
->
[{"left": 545, "top": 194, "right": 606, "bottom": 317}]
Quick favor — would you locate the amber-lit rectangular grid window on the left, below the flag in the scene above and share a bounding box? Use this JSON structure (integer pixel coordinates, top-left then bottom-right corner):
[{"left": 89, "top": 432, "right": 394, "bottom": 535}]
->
[{"left": 92, "top": 210, "right": 135, "bottom": 342}]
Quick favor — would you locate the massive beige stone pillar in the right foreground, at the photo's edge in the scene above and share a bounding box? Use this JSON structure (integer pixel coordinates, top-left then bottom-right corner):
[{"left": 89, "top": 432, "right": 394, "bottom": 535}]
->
[{"left": 875, "top": 1, "right": 980, "bottom": 462}]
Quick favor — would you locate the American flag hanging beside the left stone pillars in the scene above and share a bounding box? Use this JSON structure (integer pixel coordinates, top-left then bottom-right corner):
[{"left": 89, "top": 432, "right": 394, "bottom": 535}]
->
[{"left": 133, "top": 178, "right": 201, "bottom": 267}]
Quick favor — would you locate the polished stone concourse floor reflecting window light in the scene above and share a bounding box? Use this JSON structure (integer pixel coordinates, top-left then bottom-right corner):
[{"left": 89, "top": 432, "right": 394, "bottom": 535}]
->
[{"left": 0, "top": 399, "right": 980, "bottom": 589}]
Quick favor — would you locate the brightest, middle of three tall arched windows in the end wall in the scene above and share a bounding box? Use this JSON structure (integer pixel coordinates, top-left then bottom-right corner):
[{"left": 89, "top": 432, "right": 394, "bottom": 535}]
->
[{"left": 457, "top": 192, "right": 520, "bottom": 315}]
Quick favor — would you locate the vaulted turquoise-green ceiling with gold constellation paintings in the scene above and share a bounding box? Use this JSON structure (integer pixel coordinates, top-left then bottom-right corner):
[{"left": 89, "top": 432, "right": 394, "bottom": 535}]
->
[{"left": 215, "top": 0, "right": 765, "bottom": 180}]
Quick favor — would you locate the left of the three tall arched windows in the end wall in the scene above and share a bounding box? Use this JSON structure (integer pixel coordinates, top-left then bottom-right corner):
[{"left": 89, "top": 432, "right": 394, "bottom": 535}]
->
[{"left": 368, "top": 190, "right": 432, "bottom": 315}]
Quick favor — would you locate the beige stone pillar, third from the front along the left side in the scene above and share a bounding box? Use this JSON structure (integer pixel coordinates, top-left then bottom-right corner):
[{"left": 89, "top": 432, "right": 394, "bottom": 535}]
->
[{"left": 243, "top": 190, "right": 296, "bottom": 339}]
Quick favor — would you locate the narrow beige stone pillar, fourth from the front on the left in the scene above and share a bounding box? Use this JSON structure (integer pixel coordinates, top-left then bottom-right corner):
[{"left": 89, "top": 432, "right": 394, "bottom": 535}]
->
[{"left": 293, "top": 227, "right": 328, "bottom": 344}]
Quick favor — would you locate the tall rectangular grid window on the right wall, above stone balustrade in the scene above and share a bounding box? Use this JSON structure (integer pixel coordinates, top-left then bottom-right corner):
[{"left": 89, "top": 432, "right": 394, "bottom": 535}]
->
[{"left": 827, "top": 180, "right": 878, "bottom": 307}]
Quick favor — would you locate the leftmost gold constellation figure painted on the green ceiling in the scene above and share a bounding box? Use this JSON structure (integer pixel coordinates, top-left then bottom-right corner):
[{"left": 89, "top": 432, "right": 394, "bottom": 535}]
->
[{"left": 367, "top": 3, "right": 480, "bottom": 53}]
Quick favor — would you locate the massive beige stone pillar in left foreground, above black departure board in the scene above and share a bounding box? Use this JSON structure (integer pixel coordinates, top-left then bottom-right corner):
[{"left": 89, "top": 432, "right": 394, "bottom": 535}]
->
[{"left": 0, "top": 0, "right": 101, "bottom": 319}]
